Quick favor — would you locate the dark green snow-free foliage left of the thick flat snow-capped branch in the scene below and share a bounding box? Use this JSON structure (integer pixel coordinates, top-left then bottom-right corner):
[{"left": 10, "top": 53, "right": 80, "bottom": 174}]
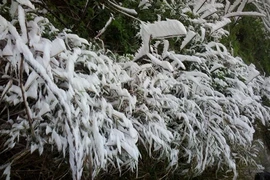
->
[{"left": 39, "top": 0, "right": 139, "bottom": 54}]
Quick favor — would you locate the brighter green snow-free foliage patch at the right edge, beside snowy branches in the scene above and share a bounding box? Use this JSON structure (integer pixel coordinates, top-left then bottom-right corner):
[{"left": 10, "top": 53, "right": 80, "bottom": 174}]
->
[{"left": 222, "top": 5, "right": 270, "bottom": 75}]
